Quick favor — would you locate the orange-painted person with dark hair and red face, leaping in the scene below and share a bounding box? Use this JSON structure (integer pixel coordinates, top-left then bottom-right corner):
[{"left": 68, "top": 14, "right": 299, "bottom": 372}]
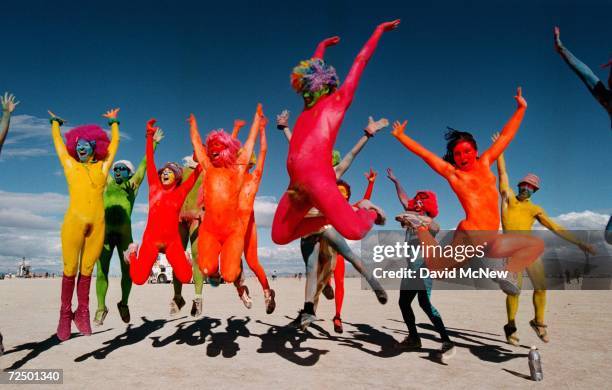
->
[{"left": 391, "top": 88, "right": 544, "bottom": 294}]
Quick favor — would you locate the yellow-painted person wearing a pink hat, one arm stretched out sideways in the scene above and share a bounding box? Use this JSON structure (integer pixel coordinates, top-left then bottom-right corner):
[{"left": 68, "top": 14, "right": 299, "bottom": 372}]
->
[{"left": 493, "top": 134, "right": 595, "bottom": 346}]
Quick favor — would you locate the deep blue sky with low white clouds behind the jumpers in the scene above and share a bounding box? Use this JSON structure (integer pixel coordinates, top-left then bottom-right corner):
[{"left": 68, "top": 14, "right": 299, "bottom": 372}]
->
[{"left": 0, "top": 1, "right": 612, "bottom": 270}]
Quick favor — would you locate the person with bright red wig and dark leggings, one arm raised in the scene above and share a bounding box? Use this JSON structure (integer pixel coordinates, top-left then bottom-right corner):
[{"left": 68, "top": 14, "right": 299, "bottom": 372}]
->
[{"left": 387, "top": 168, "right": 455, "bottom": 362}]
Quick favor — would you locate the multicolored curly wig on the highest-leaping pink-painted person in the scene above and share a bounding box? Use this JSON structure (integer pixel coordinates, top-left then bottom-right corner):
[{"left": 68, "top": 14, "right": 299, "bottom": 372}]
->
[{"left": 291, "top": 58, "right": 340, "bottom": 94}]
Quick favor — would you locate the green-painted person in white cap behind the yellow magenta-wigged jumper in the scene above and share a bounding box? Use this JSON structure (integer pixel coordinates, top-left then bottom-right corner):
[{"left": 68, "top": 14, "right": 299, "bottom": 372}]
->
[{"left": 94, "top": 126, "right": 164, "bottom": 326}]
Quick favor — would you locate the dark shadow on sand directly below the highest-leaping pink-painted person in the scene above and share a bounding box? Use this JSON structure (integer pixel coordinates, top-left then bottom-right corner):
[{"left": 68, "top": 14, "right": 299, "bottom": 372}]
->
[{"left": 253, "top": 320, "right": 329, "bottom": 366}]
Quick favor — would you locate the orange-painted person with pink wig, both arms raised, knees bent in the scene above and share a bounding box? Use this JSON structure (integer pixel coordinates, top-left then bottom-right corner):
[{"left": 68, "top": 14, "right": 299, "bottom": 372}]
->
[{"left": 189, "top": 104, "right": 263, "bottom": 283}]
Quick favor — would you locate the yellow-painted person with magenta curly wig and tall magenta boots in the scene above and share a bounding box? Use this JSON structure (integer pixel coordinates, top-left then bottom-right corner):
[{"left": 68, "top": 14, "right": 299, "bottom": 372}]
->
[{"left": 49, "top": 109, "right": 119, "bottom": 341}]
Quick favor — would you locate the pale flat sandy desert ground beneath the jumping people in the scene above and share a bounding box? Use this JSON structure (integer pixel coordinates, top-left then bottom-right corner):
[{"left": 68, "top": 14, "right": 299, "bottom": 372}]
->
[{"left": 0, "top": 279, "right": 612, "bottom": 389}]
